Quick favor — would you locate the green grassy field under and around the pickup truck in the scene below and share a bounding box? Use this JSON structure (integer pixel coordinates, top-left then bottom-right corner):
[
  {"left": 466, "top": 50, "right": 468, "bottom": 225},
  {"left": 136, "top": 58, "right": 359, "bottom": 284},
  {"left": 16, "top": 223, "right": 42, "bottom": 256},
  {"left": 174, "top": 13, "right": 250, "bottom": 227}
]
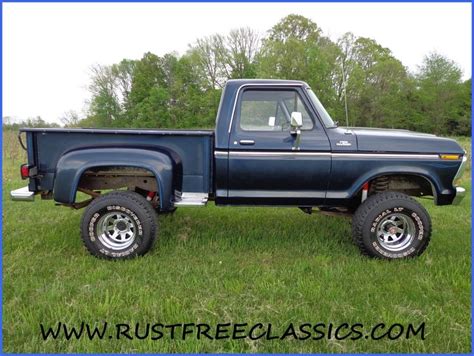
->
[{"left": 3, "top": 133, "right": 471, "bottom": 353}]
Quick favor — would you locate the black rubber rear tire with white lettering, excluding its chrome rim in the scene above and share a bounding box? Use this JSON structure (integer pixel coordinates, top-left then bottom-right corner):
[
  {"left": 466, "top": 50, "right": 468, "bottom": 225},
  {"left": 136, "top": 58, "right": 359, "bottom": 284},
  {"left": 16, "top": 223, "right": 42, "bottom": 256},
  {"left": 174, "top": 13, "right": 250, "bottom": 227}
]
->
[{"left": 81, "top": 193, "right": 156, "bottom": 259}]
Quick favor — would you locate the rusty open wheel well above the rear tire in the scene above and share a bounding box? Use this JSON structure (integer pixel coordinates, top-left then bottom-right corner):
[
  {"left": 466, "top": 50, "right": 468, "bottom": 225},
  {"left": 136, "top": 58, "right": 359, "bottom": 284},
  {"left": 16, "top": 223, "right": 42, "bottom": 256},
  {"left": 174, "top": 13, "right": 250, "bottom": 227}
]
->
[{"left": 78, "top": 166, "right": 158, "bottom": 192}]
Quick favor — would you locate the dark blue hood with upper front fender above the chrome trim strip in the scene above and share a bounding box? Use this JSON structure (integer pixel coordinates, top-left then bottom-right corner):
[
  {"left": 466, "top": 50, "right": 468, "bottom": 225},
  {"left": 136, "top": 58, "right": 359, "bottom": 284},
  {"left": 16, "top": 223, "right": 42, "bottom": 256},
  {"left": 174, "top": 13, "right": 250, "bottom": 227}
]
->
[{"left": 347, "top": 127, "right": 464, "bottom": 154}]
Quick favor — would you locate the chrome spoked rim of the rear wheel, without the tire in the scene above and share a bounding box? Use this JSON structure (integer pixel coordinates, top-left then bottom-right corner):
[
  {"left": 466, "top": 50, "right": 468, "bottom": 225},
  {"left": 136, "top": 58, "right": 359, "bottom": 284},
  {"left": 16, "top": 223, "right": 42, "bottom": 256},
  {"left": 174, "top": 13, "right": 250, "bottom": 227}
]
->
[{"left": 96, "top": 211, "right": 137, "bottom": 251}]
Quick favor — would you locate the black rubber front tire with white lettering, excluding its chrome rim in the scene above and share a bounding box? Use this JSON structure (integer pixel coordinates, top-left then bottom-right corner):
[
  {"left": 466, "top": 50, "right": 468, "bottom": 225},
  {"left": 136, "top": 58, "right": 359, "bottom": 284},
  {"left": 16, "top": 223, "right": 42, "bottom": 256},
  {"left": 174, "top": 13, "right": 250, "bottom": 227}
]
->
[{"left": 362, "top": 199, "right": 431, "bottom": 259}]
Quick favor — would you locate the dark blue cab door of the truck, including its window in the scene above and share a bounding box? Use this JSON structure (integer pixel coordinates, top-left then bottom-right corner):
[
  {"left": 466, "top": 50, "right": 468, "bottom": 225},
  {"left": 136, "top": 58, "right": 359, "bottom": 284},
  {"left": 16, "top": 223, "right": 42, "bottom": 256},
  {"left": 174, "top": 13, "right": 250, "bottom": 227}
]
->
[{"left": 228, "top": 86, "right": 331, "bottom": 205}]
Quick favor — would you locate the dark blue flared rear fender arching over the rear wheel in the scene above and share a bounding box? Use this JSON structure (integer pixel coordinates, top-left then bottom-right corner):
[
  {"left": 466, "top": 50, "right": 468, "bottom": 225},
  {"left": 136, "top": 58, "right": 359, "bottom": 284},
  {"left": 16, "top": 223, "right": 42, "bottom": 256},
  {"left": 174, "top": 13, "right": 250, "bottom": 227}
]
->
[{"left": 53, "top": 148, "right": 173, "bottom": 210}]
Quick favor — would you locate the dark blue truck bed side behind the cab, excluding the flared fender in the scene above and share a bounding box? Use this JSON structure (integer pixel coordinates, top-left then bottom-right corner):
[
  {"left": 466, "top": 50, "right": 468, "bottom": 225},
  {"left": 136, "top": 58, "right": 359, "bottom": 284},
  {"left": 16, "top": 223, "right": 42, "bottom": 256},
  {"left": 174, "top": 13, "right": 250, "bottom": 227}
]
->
[{"left": 20, "top": 128, "right": 214, "bottom": 193}]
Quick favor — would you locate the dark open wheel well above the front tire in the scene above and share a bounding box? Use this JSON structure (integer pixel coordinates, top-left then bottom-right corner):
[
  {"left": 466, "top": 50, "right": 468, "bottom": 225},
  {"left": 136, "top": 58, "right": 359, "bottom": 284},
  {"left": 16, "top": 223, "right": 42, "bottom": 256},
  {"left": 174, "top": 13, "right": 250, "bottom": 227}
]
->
[{"left": 368, "top": 174, "right": 436, "bottom": 197}]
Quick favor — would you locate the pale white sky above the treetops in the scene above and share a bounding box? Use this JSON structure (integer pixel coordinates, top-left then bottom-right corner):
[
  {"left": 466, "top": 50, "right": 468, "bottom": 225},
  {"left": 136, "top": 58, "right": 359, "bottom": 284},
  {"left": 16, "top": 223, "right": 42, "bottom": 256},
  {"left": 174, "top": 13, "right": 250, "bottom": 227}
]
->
[{"left": 2, "top": 3, "right": 472, "bottom": 123}]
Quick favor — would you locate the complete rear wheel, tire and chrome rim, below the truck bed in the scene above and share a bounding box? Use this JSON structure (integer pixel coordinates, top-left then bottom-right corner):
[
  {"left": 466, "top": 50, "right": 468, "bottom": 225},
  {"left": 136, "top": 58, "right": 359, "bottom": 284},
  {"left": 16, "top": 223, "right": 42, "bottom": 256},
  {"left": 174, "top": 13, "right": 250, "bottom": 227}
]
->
[{"left": 81, "top": 191, "right": 157, "bottom": 260}]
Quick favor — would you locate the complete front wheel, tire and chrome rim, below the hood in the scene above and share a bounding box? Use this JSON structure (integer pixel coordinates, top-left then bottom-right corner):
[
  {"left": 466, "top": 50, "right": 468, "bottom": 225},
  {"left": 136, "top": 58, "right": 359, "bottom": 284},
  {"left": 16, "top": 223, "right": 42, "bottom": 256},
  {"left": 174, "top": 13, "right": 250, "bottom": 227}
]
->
[{"left": 352, "top": 192, "right": 431, "bottom": 259}]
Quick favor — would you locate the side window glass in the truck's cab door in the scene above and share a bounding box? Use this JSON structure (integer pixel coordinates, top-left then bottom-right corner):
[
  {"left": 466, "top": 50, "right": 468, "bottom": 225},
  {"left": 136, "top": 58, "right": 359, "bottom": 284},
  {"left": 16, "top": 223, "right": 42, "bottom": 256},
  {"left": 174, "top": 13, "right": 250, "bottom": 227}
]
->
[{"left": 239, "top": 89, "right": 313, "bottom": 132}]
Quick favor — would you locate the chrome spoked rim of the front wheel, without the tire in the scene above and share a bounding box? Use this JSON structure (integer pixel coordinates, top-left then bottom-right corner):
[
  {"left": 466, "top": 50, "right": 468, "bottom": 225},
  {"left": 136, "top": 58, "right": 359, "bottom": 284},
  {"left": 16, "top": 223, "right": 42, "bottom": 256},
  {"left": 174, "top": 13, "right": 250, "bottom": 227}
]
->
[{"left": 376, "top": 213, "right": 416, "bottom": 251}]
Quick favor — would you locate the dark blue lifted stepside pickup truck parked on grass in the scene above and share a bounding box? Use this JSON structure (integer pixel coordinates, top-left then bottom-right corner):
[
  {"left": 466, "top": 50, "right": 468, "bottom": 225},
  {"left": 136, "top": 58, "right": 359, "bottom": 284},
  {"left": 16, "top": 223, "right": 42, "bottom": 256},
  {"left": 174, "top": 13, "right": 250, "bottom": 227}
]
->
[{"left": 11, "top": 80, "right": 467, "bottom": 259}]
